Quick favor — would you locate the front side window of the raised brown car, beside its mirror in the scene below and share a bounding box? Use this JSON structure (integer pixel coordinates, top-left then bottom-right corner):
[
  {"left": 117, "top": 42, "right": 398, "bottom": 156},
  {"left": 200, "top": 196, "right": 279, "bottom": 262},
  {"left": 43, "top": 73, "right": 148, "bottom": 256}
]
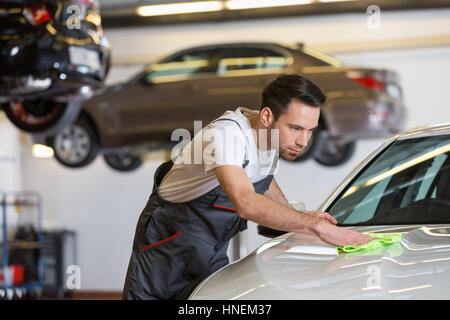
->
[{"left": 146, "top": 49, "right": 217, "bottom": 83}]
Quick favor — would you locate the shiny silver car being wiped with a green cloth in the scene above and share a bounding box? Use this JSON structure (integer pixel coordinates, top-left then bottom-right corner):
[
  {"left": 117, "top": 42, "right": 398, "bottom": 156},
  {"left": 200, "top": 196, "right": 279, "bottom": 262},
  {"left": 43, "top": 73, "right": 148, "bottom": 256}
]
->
[{"left": 189, "top": 123, "right": 450, "bottom": 300}]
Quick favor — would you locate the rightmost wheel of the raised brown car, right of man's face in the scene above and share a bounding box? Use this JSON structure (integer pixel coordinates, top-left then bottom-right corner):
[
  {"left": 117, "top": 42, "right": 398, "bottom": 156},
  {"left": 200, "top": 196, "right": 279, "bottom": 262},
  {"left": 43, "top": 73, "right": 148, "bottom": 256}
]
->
[{"left": 314, "top": 139, "right": 356, "bottom": 167}]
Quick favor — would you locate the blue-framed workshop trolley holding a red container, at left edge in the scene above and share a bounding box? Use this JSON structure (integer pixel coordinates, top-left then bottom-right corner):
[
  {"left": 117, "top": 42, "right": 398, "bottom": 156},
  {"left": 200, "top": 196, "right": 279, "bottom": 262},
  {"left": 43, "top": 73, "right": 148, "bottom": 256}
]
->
[{"left": 0, "top": 191, "right": 43, "bottom": 300}]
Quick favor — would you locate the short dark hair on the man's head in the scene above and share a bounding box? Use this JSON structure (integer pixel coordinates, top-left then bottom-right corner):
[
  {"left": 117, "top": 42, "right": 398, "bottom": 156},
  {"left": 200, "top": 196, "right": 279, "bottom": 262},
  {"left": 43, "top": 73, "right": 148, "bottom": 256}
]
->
[{"left": 261, "top": 74, "right": 327, "bottom": 121}]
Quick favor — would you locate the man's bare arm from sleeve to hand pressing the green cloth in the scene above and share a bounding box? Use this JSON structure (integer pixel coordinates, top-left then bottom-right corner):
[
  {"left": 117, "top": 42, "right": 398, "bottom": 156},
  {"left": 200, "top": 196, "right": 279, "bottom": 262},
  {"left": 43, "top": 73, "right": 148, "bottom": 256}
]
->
[{"left": 214, "top": 166, "right": 373, "bottom": 246}]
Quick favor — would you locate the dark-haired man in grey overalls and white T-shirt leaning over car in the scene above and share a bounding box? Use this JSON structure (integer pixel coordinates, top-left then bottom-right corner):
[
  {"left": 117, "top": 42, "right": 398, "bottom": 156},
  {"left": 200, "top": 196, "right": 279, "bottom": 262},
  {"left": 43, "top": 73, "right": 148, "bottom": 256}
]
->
[{"left": 123, "top": 75, "right": 372, "bottom": 299}]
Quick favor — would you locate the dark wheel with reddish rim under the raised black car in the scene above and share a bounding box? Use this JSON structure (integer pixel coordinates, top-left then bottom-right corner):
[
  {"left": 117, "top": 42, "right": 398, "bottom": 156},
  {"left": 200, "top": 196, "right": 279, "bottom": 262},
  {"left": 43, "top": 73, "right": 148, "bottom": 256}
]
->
[{"left": 3, "top": 99, "right": 81, "bottom": 136}]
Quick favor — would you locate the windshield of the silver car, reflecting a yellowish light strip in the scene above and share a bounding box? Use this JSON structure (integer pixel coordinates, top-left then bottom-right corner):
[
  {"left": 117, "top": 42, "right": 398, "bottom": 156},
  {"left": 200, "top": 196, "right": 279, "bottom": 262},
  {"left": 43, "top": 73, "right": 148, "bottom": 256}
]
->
[{"left": 327, "top": 135, "right": 450, "bottom": 225}]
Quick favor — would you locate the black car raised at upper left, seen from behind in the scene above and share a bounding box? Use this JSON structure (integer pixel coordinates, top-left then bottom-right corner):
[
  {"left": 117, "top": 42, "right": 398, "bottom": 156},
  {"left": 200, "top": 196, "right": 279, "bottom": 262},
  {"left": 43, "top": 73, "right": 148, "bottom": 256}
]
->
[{"left": 0, "top": 0, "right": 110, "bottom": 135}]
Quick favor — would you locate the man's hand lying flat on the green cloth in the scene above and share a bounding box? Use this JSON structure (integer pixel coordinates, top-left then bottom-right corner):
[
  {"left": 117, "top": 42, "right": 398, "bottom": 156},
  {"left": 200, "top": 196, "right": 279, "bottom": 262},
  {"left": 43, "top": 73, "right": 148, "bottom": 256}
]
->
[{"left": 315, "top": 220, "right": 375, "bottom": 247}]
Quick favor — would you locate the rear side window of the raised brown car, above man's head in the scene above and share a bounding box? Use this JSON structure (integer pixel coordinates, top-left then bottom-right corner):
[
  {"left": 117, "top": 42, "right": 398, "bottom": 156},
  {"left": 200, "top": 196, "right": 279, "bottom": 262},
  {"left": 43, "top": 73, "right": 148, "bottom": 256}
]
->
[{"left": 217, "top": 47, "right": 288, "bottom": 75}]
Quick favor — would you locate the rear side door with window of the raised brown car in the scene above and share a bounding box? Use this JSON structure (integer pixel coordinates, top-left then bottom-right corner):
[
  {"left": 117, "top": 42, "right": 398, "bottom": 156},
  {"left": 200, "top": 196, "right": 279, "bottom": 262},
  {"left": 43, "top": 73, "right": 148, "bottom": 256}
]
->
[{"left": 206, "top": 45, "right": 289, "bottom": 115}]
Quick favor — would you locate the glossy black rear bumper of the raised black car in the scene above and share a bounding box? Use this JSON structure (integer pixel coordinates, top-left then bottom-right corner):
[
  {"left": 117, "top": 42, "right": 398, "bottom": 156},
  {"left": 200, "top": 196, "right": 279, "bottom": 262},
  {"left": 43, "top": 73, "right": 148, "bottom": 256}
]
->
[{"left": 0, "top": 39, "right": 110, "bottom": 102}]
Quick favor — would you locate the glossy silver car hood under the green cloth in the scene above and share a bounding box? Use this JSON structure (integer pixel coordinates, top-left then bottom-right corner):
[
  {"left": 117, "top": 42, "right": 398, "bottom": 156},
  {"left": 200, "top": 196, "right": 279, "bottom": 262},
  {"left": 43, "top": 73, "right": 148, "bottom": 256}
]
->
[{"left": 190, "top": 225, "right": 450, "bottom": 300}]
